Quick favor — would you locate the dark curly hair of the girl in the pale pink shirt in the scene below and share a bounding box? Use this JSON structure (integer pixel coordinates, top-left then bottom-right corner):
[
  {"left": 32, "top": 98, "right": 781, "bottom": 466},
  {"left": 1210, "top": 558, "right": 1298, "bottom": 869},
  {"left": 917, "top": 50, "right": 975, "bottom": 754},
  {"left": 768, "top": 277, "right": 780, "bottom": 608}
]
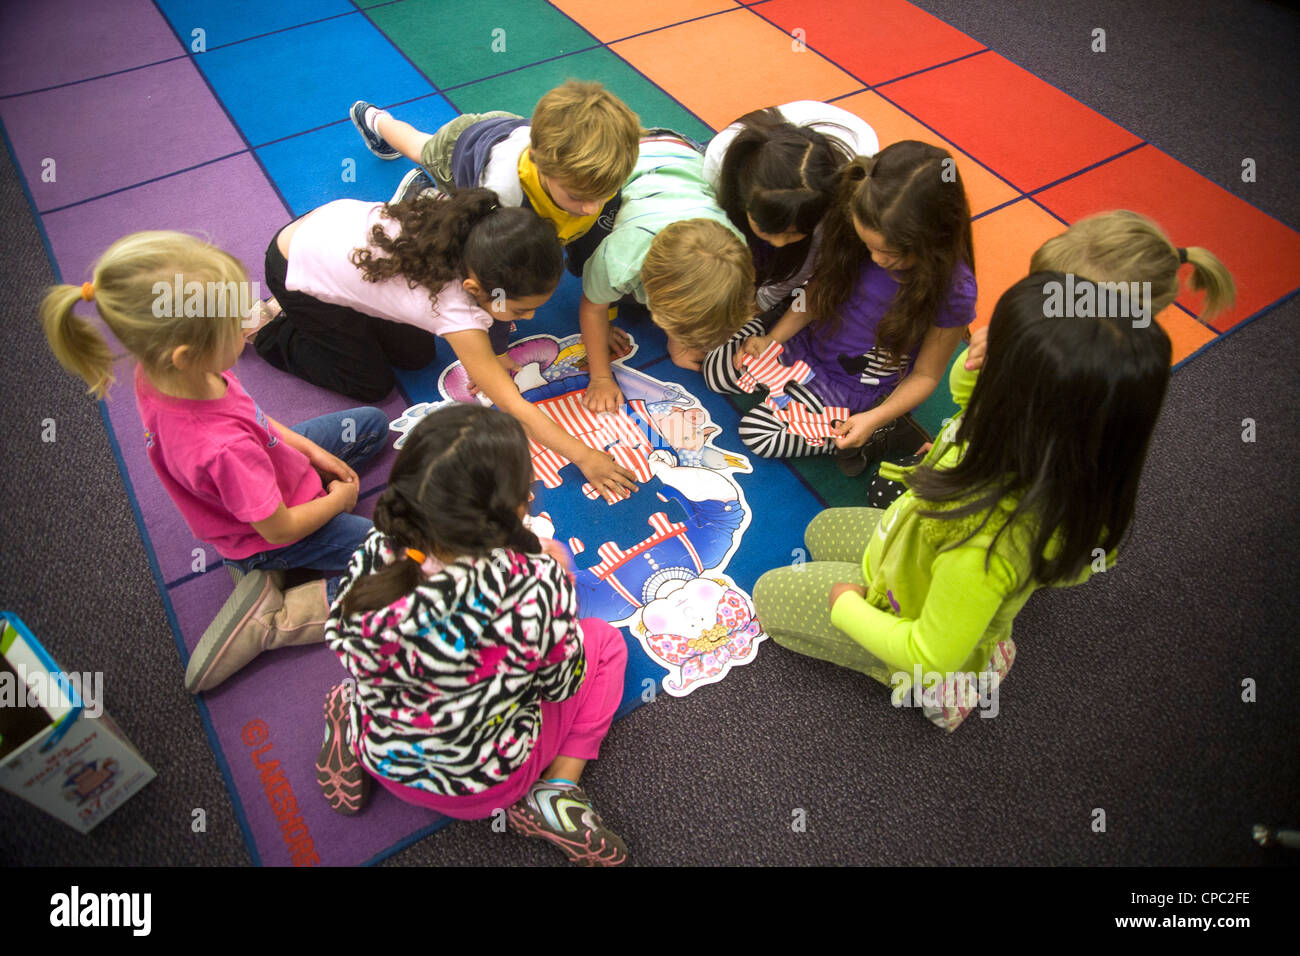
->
[{"left": 352, "top": 189, "right": 564, "bottom": 310}]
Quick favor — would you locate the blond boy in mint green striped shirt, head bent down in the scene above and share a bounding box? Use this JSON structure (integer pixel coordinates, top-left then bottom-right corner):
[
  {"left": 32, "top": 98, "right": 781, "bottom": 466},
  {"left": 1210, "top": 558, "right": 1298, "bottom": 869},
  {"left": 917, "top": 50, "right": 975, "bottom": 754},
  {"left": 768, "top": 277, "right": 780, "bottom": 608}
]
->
[{"left": 579, "top": 130, "right": 754, "bottom": 411}]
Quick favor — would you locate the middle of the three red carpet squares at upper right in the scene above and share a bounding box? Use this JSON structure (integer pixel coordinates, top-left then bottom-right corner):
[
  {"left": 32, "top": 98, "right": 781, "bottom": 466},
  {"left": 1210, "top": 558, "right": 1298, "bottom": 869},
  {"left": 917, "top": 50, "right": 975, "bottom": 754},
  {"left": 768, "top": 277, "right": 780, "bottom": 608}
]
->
[{"left": 879, "top": 52, "right": 1141, "bottom": 193}]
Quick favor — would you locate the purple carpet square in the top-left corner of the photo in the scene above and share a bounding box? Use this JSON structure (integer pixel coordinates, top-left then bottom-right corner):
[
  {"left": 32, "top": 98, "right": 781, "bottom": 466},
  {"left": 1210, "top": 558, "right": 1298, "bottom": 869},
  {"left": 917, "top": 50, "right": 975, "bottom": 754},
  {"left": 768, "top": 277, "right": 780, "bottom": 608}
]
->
[{"left": 0, "top": 0, "right": 186, "bottom": 96}]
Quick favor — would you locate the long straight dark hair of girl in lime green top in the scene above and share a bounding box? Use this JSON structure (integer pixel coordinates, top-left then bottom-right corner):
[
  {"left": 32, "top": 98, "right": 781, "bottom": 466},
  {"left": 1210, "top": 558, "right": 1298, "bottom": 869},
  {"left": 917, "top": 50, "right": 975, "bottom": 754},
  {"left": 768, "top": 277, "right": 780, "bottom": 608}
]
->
[{"left": 907, "top": 272, "right": 1171, "bottom": 584}]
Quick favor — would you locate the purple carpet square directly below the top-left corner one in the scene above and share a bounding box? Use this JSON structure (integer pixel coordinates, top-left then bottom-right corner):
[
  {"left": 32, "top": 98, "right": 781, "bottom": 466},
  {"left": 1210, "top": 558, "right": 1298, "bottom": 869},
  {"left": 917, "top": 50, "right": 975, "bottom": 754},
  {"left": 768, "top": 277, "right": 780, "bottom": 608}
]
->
[{"left": 0, "top": 60, "right": 244, "bottom": 211}]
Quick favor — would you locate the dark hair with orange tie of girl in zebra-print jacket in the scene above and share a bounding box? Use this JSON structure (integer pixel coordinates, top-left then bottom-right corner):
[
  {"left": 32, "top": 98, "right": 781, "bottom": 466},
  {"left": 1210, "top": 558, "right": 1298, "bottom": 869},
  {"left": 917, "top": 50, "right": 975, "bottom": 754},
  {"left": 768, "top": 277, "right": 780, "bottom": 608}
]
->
[{"left": 342, "top": 403, "right": 542, "bottom": 617}]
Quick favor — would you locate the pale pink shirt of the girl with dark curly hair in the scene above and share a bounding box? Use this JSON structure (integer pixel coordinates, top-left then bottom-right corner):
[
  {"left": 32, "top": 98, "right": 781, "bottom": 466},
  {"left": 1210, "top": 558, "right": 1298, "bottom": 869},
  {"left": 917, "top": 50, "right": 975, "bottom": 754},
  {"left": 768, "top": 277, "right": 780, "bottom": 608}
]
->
[{"left": 285, "top": 199, "right": 493, "bottom": 336}]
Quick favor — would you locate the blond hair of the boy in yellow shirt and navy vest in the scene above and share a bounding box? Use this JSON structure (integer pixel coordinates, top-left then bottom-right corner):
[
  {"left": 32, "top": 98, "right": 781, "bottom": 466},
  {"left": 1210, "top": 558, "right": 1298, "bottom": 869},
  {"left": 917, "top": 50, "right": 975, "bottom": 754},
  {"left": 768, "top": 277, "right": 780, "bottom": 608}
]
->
[{"left": 530, "top": 79, "right": 641, "bottom": 199}]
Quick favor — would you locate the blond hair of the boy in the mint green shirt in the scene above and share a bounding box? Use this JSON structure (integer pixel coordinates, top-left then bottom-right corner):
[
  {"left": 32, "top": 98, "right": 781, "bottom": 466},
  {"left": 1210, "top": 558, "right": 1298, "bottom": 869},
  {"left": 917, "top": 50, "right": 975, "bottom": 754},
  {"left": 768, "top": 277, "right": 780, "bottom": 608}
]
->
[{"left": 641, "top": 219, "right": 754, "bottom": 349}]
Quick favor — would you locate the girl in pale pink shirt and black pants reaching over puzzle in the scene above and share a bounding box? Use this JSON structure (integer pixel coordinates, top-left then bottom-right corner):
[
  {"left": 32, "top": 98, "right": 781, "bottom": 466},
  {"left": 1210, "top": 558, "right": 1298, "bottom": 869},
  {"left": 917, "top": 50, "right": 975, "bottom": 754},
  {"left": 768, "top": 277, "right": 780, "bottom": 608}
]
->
[{"left": 245, "top": 189, "right": 636, "bottom": 494}]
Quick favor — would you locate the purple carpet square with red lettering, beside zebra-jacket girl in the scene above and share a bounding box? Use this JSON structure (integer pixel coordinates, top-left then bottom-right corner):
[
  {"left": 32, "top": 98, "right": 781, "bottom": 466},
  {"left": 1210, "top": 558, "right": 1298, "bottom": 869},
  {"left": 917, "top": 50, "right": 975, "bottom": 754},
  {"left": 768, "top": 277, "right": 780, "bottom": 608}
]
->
[{"left": 170, "top": 572, "right": 445, "bottom": 866}]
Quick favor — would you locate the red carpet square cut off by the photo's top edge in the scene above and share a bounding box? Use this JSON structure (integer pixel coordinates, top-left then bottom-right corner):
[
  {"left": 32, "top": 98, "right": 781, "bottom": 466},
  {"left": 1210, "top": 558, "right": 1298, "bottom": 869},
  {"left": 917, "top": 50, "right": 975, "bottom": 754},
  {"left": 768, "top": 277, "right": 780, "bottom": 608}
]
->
[{"left": 754, "top": 0, "right": 984, "bottom": 85}]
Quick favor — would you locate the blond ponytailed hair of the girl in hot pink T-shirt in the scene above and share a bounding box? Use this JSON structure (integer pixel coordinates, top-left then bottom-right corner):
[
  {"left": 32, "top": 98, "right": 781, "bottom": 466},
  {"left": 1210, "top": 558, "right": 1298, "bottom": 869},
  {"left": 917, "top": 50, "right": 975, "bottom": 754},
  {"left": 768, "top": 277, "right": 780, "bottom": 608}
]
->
[{"left": 40, "top": 232, "right": 248, "bottom": 398}]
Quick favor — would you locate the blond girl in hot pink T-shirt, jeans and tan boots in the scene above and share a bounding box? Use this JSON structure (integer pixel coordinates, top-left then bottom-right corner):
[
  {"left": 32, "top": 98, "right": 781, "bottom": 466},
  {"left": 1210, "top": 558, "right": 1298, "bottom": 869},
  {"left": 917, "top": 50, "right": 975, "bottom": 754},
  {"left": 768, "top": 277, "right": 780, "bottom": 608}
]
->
[{"left": 40, "top": 232, "right": 387, "bottom": 693}]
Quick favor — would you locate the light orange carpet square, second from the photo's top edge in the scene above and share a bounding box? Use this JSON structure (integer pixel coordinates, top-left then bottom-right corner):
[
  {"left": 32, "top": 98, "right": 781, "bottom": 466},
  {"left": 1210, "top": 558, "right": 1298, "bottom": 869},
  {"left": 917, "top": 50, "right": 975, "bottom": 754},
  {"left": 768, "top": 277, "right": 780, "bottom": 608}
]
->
[{"left": 610, "top": 9, "right": 862, "bottom": 129}]
